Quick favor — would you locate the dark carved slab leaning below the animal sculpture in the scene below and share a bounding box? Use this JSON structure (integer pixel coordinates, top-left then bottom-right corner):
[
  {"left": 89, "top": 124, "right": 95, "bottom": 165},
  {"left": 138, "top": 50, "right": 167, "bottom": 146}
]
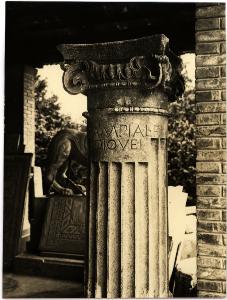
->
[{"left": 39, "top": 196, "right": 86, "bottom": 256}]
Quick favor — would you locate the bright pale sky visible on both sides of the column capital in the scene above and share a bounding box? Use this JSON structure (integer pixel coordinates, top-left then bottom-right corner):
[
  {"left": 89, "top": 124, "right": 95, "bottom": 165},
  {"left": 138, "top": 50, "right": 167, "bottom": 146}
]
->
[{"left": 38, "top": 54, "right": 195, "bottom": 123}]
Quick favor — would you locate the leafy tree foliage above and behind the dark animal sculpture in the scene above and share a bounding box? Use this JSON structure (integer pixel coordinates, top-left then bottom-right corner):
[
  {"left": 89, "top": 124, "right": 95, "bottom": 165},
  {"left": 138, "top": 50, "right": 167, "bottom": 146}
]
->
[{"left": 35, "top": 76, "right": 77, "bottom": 167}]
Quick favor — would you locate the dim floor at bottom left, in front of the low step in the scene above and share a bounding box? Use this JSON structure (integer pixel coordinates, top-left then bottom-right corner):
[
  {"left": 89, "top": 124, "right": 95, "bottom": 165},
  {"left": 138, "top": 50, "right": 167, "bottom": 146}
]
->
[{"left": 2, "top": 273, "right": 84, "bottom": 298}]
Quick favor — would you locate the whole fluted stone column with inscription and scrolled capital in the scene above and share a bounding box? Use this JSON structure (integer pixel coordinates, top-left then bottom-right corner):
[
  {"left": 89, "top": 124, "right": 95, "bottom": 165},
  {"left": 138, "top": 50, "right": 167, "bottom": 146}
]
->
[{"left": 59, "top": 35, "right": 183, "bottom": 298}]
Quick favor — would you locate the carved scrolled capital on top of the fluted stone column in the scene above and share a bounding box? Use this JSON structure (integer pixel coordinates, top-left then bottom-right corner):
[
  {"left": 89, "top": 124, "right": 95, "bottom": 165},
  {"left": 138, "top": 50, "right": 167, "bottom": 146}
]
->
[{"left": 58, "top": 34, "right": 184, "bottom": 100}]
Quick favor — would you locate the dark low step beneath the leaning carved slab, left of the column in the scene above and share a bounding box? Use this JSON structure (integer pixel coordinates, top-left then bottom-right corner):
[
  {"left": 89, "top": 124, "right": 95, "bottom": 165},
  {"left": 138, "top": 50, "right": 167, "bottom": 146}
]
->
[{"left": 14, "top": 253, "right": 84, "bottom": 282}]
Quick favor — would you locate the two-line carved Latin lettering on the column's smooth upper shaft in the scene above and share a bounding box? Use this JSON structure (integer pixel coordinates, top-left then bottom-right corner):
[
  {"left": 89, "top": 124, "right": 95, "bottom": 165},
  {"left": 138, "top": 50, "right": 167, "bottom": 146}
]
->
[{"left": 94, "top": 124, "right": 161, "bottom": 151}]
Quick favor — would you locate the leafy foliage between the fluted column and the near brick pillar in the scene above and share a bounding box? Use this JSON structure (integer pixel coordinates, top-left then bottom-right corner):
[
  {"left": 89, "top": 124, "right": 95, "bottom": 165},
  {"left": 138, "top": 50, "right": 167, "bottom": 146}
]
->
[{"left": 168, "top": 90, "right": 196, "bottom": 200}]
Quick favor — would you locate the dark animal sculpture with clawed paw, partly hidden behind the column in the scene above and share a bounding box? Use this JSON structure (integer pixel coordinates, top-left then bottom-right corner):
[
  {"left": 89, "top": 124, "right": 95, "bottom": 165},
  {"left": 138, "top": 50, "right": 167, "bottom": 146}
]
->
[{"left": 44, "top": 129, "right": 87, "bottom": 196}]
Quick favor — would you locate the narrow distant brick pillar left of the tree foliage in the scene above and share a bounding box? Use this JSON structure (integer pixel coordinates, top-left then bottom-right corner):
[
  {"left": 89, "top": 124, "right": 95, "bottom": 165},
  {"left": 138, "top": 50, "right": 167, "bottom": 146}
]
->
[{"left": 23, "top": 66, "right": 36, "bottom": 164}]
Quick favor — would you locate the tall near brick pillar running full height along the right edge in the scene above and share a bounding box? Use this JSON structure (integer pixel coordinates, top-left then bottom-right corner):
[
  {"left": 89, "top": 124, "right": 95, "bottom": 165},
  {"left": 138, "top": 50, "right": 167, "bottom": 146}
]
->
[{"left": 196, "top": 3, "right": 226, "bottom": 297}]
